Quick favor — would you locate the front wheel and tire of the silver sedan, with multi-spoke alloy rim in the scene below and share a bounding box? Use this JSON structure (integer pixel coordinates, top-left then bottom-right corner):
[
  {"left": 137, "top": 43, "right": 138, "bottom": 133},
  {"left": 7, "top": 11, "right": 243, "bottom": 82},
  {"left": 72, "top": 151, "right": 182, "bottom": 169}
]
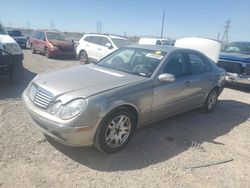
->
[{"left": 94, "top": 108, "right": 136, "bottom": 153}]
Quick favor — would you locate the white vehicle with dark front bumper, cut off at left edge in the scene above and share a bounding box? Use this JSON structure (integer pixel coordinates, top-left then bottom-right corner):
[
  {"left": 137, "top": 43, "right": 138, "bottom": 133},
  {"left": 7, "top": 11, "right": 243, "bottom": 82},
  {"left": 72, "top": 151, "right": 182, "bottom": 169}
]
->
[{"left": 0, "top": 23, "right": 23, "bottom": 81}]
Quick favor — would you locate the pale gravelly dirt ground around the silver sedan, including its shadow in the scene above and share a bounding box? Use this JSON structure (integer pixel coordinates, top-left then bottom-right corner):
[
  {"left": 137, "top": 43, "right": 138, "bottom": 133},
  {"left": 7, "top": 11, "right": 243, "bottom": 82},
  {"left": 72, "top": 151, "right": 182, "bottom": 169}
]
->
[{"left": 0, "top": 50, "right": 250, "bottom": 188}]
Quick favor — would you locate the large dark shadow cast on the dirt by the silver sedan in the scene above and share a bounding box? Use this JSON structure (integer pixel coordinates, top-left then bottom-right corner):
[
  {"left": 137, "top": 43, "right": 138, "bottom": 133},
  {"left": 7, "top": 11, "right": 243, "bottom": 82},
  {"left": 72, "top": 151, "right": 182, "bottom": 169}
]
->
[{"left": 48, "top": 100, "right": 250, "bottom": 171}]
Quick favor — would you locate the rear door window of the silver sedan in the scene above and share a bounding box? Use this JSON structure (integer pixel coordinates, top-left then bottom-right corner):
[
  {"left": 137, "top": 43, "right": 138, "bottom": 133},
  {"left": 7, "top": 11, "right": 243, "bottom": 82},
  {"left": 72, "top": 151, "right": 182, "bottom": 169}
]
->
[{"left": 189, "top": 54, "right": 212, "bottom": 74}]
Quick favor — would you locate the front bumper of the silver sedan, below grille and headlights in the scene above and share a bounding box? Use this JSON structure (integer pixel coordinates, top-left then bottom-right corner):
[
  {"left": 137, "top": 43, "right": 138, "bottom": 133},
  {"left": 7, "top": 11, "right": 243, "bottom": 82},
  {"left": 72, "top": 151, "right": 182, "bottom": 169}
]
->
[{"left": 22, "top": 91, "right": 95, "bottom": 146}]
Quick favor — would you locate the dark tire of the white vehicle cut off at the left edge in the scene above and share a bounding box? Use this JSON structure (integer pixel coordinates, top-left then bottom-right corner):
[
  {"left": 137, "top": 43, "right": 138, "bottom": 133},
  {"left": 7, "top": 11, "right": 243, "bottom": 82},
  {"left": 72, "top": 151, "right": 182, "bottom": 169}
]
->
[{"left": 10, "top": 61, "right": 24, "bottom": 83}]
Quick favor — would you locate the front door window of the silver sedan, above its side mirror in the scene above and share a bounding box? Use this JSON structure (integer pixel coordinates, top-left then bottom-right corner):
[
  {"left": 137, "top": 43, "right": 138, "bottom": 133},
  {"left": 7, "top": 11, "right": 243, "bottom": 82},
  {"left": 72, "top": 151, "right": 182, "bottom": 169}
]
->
[{"left": 163, "top": 53, "right": 188, "bottom": 76}]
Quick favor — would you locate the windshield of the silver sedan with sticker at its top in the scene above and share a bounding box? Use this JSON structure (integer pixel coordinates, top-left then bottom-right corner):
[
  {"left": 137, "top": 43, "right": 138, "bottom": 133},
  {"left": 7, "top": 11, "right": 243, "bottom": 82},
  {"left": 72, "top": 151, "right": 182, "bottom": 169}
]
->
[{"left": 97, "top": 48, "right": 166, "bottom": 77}]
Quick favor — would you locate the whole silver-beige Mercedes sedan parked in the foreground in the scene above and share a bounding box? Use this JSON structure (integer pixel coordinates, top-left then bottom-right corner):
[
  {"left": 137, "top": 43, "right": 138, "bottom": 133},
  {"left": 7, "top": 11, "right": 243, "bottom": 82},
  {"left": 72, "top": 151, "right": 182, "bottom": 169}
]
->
[{"left": 23, "top": 37, "right": 225, "bottom": 153}]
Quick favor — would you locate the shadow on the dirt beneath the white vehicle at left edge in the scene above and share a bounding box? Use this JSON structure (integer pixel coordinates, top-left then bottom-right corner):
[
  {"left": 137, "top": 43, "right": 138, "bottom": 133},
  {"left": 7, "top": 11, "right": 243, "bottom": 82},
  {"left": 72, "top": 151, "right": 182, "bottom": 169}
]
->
[{"left": 0, "top": 68, "right": 36, "bottom": 100}]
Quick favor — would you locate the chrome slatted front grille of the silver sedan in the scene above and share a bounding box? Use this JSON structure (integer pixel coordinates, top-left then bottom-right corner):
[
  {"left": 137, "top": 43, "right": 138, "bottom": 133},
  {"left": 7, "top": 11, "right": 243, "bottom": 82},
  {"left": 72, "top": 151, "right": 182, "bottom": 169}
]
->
[{"left": 29, "top": 84, "right": 53, "bottom": 109}]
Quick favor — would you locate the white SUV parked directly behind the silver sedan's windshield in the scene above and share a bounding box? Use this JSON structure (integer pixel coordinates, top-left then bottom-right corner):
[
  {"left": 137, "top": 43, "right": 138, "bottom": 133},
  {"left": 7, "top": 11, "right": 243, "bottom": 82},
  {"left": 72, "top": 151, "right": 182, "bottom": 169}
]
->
[{"left": 76, "top": 34, "right": 133, "bottom": 64}]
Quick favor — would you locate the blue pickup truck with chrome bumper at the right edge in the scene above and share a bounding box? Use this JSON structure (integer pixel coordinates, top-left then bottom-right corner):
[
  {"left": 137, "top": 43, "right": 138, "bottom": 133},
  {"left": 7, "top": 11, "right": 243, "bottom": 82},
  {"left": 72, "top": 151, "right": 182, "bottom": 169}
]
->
[{"left": 218, "top": 42, "right": 250, "bottom": 85}]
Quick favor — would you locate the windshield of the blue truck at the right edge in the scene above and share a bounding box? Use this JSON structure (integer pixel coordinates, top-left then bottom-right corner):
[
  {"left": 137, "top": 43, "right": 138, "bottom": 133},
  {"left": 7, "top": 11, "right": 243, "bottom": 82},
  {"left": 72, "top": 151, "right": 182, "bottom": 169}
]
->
[{"left": 223, "top": 42, "right": 250, "bottom": 54}]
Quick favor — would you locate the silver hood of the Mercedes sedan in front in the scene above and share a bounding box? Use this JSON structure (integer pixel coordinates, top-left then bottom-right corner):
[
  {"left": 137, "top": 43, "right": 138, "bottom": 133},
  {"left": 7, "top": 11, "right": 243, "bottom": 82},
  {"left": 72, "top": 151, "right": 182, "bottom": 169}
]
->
[{"left": 33, "top": 64, "right": 146, "bottom": 98}]
